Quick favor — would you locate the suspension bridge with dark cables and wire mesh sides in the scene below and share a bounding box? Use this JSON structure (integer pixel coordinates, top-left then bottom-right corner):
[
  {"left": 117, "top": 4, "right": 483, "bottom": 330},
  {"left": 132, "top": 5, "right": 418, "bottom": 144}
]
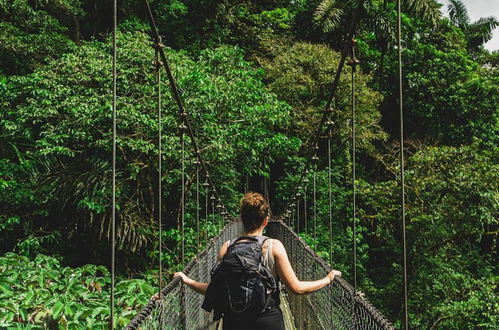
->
[{"left": 111, "top": 0, "right": 408, "bottom": 329}]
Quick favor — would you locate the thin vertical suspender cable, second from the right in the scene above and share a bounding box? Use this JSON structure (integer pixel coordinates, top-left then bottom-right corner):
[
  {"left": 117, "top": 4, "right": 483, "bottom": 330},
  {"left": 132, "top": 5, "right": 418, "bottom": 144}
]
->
[{"left": 350, "top": 39, "right": 357, "bottom": 292}]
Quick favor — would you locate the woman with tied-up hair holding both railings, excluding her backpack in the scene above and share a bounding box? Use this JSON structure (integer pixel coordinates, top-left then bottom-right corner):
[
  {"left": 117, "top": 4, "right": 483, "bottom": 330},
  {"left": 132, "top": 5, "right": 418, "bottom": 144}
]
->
[{"left": 174, "top": 192, "right": 341, "bottom": 330}]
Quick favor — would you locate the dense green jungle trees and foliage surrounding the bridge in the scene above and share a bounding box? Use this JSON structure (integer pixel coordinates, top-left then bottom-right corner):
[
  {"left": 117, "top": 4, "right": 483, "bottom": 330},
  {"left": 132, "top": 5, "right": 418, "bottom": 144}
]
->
[{"left": 0, "top": 0, "right": 499, "bottom": 329}]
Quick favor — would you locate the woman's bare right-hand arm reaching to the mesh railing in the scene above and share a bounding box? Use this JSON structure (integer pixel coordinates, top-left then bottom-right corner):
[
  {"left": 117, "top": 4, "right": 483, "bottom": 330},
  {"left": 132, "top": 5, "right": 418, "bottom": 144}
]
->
[{"left": 272, "top": 239, "right": 341, "bottom": 294}]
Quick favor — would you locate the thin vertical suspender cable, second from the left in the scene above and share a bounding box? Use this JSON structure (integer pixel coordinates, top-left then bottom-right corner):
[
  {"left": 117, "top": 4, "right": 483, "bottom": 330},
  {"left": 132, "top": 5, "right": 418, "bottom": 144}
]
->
[{"left": 156, "top": 51, "right": 163, "bottom": 299}]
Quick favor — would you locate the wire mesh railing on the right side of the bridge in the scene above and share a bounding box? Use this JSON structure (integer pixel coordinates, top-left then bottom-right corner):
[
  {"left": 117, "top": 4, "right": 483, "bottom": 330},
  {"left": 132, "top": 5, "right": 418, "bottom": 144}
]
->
[{"left": 266, "top": 221, "right": 394, "bottom": 329}]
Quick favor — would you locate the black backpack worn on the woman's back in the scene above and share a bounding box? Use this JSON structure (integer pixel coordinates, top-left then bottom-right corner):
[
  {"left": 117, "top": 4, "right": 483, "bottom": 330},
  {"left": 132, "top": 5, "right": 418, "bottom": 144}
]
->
[{"left": 201, "top": 236, "right": 279, "bottom": 321}]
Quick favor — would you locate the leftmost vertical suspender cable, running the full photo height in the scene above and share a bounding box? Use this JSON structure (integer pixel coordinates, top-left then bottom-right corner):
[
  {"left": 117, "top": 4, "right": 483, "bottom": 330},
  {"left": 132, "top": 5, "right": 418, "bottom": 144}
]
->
[{"left": 110, "top": 0, "right": 118, "bottom": 329}]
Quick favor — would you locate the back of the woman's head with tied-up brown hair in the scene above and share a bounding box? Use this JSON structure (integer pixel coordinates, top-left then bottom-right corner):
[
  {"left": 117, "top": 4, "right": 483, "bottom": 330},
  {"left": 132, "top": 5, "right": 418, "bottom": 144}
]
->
[{"left": 241, "top": 192, "right": 269, "bottom": 231}]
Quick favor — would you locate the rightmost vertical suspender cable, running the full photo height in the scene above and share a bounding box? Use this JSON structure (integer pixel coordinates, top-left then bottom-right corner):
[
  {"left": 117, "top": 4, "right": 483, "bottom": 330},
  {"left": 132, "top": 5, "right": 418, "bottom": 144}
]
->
[{"left": 397, "top": 0, "right": 409, "bottom": 329}]
